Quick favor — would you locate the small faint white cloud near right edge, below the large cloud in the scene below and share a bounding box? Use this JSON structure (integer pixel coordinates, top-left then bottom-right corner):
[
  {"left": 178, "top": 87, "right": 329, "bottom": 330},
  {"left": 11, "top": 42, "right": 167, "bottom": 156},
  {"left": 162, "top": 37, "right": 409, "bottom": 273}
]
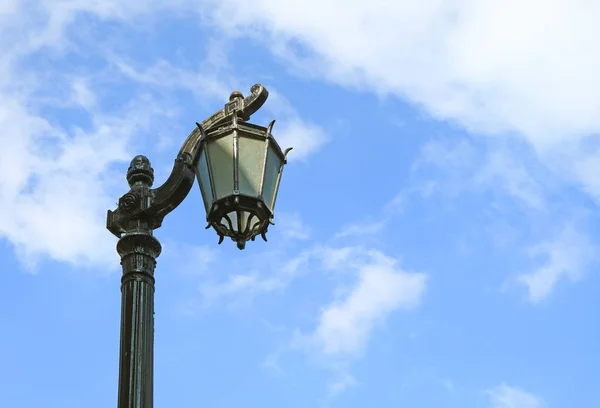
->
[{"left": 515, "top": 225, "right": 596, "bottom": 303}]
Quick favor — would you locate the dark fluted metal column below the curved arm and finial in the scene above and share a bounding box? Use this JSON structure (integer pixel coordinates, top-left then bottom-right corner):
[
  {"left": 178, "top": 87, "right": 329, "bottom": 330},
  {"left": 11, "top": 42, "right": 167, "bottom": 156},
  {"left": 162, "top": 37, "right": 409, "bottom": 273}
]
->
[{"left": 117, "top": 228, "right": 161, "bottom": 408}]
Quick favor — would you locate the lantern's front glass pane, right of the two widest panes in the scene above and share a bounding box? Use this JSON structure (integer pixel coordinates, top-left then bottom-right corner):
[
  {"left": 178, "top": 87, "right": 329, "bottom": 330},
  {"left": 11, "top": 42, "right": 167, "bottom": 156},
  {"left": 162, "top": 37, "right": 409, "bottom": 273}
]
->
[{"left": 238, "top": 134, "right": 266, "bottom": 197}]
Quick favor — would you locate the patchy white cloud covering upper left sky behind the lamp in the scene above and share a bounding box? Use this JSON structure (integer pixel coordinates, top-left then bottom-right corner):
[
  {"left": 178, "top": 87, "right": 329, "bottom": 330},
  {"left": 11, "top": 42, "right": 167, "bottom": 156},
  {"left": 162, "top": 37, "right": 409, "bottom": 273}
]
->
[{"left": 0, "top": 1, "right": 324, "bottom": 267}]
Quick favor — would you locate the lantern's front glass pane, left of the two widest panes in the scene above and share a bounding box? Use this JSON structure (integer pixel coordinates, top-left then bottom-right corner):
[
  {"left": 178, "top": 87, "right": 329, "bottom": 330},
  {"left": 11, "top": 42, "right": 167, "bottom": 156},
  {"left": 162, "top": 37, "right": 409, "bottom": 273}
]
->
[{"left": 206, "top": 134, "right": 233, "bottom": 199}]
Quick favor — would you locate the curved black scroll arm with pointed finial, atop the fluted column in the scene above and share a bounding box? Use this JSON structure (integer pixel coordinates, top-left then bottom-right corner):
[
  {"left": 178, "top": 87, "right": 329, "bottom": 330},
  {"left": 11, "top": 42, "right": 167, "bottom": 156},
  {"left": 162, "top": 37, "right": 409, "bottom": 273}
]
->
[{"left": 106, "top": 84, "right": 269, "bottom": 238}]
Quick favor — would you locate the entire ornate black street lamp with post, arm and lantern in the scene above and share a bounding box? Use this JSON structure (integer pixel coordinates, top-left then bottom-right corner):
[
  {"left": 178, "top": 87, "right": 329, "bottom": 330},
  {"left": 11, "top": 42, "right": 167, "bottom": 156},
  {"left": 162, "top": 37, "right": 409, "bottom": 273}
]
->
[{"left": 106, "top": 84, "right": 291, "bottom": 408}]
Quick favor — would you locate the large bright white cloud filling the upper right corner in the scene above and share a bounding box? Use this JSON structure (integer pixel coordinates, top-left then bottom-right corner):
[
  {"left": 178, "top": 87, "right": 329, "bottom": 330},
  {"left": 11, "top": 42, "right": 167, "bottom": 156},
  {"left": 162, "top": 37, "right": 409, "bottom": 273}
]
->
[{"left": 196, "top": 0, "right": 600, "bottom": 208}]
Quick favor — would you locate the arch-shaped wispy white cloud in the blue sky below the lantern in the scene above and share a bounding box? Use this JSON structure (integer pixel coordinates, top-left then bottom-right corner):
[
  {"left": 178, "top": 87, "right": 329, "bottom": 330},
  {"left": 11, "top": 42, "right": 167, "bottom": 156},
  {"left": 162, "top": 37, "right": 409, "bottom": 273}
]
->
[{"left": 173, "top": 241, "right": 427, "bottom": 398}]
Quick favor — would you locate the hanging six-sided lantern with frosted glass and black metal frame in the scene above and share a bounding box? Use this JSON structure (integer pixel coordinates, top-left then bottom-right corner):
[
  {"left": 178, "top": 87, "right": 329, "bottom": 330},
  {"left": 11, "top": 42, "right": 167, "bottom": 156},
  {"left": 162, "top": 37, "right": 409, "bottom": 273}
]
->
[{"left": 194, "top": 103, "right": 291, "bottom": 249}]
